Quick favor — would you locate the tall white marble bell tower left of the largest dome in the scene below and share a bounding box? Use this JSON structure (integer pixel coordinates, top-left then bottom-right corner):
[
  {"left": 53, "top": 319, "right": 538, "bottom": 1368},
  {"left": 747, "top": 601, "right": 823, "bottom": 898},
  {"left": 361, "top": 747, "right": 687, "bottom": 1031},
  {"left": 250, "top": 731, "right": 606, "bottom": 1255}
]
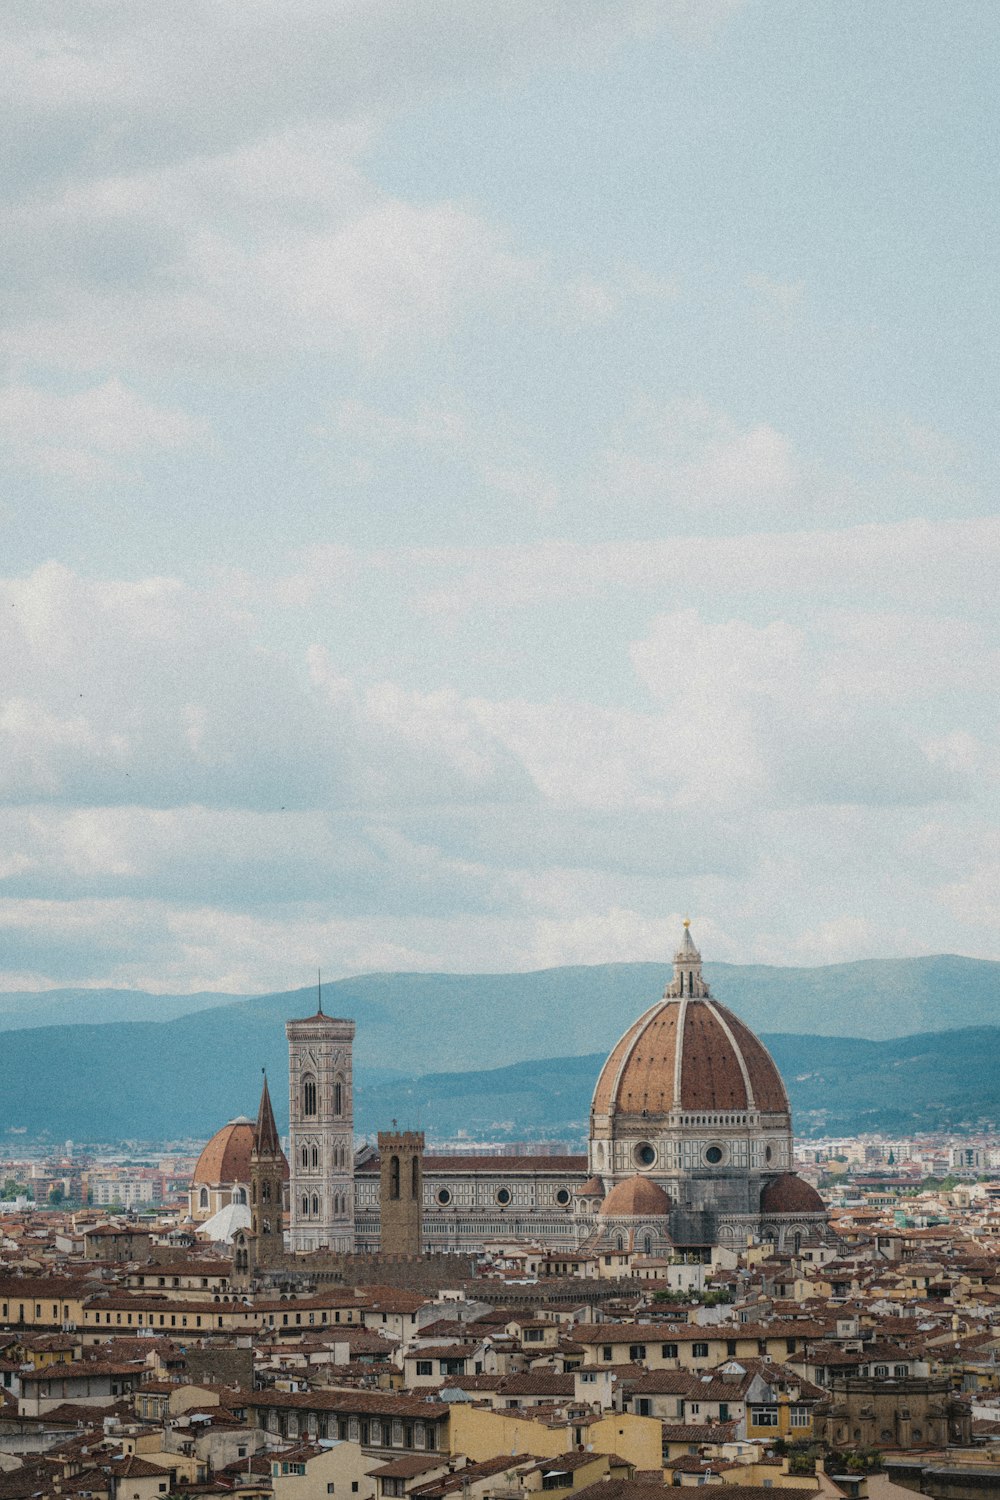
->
[{"left": 285, "top": 998, "right": 354, "bottom": 1253}]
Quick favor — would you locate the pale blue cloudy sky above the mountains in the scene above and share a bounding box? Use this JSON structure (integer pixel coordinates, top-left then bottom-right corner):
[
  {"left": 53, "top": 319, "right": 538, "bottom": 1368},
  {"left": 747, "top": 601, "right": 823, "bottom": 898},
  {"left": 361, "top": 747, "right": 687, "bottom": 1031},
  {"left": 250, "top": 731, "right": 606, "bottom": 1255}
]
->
[{"left": 0, "top": 0, "right": 1000, "bottom": 990}]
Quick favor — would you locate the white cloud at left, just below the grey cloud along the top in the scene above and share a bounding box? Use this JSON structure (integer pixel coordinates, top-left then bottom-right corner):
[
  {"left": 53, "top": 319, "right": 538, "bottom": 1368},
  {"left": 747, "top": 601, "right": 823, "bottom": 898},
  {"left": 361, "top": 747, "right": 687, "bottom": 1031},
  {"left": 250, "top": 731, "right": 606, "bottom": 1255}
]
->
[{"left": 7, "top": 147, "right": 544, "bottom": 371}]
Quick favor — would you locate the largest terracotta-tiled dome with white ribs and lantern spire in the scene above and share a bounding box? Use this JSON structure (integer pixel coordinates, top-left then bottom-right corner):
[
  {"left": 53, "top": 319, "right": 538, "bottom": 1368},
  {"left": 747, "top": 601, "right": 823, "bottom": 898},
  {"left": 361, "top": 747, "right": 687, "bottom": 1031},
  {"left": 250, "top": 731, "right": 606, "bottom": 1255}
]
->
[{"left": 594, "top": 924, "right": 789, "bottom": 1115}]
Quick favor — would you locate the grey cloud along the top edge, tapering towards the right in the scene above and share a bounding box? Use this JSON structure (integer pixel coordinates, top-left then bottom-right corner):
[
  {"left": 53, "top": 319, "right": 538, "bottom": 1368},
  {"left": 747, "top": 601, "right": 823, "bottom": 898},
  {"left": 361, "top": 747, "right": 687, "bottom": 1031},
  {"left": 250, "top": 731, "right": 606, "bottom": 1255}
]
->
[{"left": 0, "top": 0, "right": 738, "bottom": 171}]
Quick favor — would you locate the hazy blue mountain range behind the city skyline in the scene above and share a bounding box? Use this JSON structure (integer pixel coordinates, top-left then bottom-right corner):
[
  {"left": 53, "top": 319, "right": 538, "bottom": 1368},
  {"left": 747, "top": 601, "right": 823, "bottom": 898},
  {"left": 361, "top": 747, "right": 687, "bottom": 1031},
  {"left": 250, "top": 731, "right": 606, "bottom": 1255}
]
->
[{"left": 0, "top": 956, "right": 1000, "bottom": 1146}]
